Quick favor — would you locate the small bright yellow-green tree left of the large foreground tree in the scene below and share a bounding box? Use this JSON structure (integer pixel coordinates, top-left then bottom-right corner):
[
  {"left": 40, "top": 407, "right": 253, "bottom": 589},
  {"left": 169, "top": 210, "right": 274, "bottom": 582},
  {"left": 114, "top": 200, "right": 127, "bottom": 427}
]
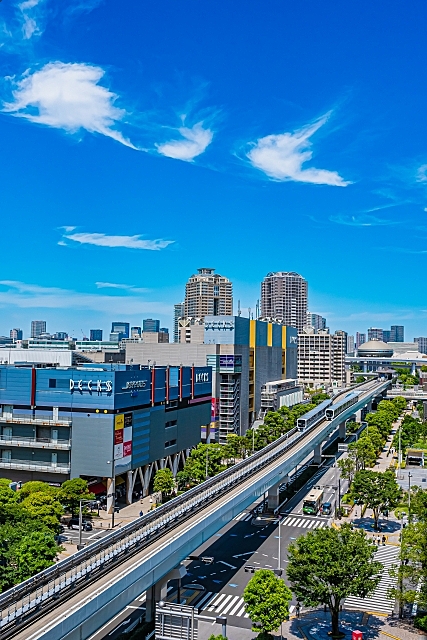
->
[{"left": 243, "top": 569, "right": 292, "bottom": 633}]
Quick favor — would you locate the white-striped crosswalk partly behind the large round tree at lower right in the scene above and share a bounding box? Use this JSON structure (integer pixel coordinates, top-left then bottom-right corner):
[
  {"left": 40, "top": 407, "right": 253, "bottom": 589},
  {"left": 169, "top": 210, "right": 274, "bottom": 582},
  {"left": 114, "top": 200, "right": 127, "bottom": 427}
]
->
[{"left": 344, "top": 546, "right": 399, "bottom": 614}]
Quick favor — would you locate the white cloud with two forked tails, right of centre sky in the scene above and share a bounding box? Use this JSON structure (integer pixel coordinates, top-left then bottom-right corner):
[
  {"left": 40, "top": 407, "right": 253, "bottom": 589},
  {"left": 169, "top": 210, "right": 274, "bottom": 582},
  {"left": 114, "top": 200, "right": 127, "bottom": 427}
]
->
[{"left": 246, "top": 113, "right": 351, "bottom": 187}]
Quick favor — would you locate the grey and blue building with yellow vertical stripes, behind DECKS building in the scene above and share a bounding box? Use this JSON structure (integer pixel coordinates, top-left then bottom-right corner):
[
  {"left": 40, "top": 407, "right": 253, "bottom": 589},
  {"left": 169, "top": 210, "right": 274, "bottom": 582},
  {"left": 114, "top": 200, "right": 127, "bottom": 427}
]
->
[{"left": 125, "top": 316, "right": 297, "bottom": 443}]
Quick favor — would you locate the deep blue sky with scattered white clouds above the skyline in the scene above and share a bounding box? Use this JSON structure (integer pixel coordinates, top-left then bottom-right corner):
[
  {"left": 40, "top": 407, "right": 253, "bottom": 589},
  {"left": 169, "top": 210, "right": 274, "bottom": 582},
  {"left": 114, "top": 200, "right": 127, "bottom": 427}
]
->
[{"left": 0, "top": 0, "right": 427, "bottom": 340}]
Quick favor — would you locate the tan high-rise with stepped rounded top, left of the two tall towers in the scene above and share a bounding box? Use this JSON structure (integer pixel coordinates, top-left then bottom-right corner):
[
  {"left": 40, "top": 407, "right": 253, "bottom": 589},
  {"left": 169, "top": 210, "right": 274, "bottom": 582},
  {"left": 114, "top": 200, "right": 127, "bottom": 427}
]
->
[{"left": 184, "top": 268, "right": 233, "bottom": 320}]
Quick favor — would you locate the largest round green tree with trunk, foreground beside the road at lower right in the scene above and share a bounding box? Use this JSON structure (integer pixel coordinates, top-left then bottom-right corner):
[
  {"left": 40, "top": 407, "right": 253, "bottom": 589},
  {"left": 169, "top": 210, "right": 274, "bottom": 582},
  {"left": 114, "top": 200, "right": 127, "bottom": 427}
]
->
[{"left": 287, "top": 524, "right": 382, "bottom": 637}]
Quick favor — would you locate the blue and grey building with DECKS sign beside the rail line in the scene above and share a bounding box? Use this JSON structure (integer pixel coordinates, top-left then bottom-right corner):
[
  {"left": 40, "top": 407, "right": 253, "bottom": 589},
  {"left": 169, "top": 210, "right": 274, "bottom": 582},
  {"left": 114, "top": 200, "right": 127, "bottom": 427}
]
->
[{"left": 0, "top": 363, "right": 212, "bottom": 502}]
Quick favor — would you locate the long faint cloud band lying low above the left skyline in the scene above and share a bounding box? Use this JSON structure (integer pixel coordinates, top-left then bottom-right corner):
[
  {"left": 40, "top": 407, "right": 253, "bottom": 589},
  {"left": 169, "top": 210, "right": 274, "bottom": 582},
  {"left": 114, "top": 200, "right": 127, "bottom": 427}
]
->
[{"left": 0, "top": 280, "right": 170, "bottom": 315}]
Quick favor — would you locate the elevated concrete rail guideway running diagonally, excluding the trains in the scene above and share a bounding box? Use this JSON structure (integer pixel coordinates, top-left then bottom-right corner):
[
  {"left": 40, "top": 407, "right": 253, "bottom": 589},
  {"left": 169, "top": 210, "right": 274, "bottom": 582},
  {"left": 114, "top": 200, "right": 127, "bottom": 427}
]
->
[{"left": 0, "top": 381, "right": 389, "bottom": 640}]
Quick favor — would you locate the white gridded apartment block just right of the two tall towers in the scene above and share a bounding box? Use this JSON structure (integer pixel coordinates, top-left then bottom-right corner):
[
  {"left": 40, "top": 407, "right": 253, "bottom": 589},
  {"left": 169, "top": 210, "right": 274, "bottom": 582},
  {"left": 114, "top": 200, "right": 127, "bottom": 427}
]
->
[{"left": 298, "top": 327, "right": 347, "bottom": 389}]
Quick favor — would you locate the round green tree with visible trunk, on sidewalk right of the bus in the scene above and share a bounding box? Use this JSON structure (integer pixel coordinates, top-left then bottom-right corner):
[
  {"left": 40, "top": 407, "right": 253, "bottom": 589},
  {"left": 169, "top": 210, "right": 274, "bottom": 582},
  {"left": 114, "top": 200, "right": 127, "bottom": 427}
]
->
[{"left": 351, "top": 469, "right": 401, "bottom": 529}]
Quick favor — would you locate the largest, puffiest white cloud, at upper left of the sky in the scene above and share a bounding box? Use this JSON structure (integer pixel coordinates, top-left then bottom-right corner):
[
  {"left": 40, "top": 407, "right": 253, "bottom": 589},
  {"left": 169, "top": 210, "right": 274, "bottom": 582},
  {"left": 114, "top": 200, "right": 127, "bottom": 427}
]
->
[{"left": 3, "top": 62, "right": 135, "bottom": 149}]
